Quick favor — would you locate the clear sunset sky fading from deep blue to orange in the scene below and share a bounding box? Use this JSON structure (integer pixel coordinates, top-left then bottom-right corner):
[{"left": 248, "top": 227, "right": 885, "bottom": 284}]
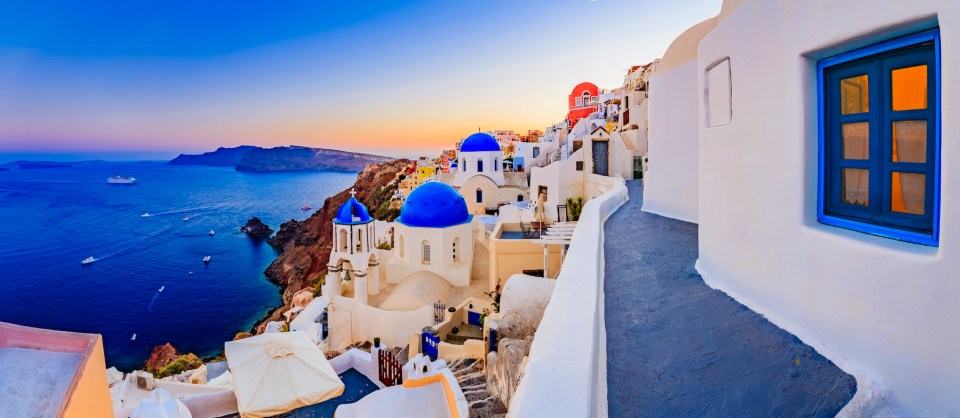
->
[{"left": 0, "top": 0, "right": 721, "bottom": 162}]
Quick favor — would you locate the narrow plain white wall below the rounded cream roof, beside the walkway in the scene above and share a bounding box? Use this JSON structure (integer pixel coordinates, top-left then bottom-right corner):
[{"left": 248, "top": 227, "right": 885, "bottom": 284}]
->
[{"left": 643, "top": 60, "right": 700, "bottom": 222}]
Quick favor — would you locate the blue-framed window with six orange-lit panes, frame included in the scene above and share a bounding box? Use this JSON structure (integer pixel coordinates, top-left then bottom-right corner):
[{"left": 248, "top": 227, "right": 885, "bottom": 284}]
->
[{"left": 817, "top": 29, "right": 940, "bottom": 246}]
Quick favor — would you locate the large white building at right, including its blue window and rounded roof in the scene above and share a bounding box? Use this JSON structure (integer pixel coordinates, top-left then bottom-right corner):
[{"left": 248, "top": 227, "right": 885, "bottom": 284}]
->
[{"left": 644, "top": 0, "right": 960, "bottom": 416}]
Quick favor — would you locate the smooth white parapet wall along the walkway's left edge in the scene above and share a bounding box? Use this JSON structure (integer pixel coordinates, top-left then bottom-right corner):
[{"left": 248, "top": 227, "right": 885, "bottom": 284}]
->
[{"left": 508, "top": 181, "right": 629, "bottom": 418}]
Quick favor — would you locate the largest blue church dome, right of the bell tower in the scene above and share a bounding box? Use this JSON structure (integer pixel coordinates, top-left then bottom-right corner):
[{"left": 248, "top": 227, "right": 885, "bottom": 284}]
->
[{"left": 397, "top": 181, "right": 473, "bottom": 228}]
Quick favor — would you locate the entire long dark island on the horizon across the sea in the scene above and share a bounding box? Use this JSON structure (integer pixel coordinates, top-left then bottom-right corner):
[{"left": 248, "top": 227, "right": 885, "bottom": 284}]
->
[{"left": 168, "top": 145, "right": 395, "bottom": 172}]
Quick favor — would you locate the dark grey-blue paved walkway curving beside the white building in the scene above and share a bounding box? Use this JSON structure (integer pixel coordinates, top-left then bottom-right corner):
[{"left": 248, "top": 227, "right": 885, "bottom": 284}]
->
[{"left": 604, "top": 181, "right": 856, "bottom": 417}]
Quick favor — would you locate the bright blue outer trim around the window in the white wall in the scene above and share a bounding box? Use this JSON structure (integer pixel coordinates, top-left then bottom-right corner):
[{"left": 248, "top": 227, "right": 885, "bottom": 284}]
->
[{"left": 817, "top": 29, "right": 942, "bottom": 247}]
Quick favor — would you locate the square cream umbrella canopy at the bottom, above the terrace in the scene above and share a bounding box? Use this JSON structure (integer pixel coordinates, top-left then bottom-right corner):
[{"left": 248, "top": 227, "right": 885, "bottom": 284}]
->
[{"left": 224, "top": 331, "right": 344, "bottom": 418}]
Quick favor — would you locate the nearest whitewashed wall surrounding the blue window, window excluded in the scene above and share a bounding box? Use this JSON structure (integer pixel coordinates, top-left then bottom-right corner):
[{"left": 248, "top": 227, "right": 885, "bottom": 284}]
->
[{"left": 696, "top": 0, "right": 960, "bottom": 416}]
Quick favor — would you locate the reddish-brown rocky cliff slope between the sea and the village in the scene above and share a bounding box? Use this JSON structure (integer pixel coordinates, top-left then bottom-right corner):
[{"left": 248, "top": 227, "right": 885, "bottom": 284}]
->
[{"left": 255, "top": 160, "right": 412, "bottom": 333}]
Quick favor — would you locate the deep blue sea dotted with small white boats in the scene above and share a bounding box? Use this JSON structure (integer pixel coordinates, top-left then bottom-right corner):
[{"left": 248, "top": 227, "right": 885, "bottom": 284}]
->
[{"left": 0, "top": 163, "right": 356, "bottom": 371}]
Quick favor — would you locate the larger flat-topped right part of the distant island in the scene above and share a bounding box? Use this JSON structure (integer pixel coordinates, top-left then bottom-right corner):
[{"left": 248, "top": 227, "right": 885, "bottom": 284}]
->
[{"left": 237, "top": 146, "right": 393, "bottom": 172}]
